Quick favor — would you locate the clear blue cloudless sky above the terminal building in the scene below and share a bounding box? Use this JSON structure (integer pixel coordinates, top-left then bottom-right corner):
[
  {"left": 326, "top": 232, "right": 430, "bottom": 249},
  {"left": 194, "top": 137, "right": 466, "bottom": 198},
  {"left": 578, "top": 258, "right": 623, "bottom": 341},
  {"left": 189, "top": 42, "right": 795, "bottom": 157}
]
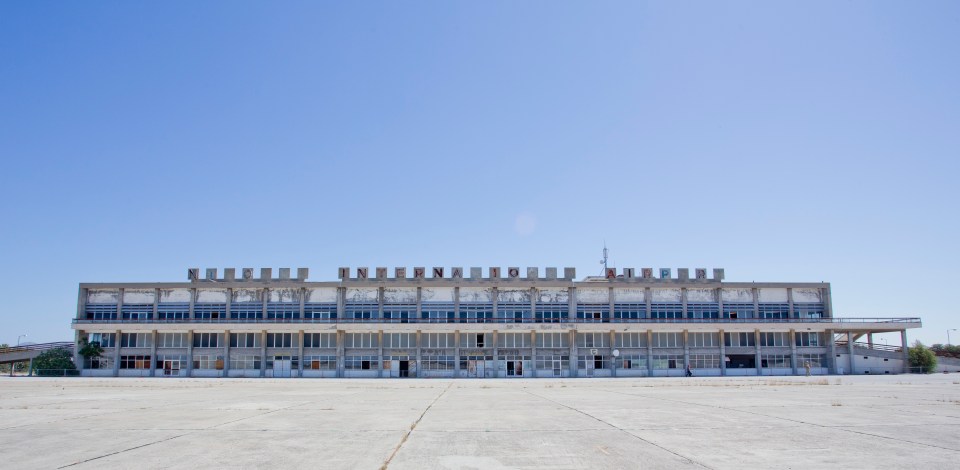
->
[{"left": 0, "top": 1, "right": 960, "bottom": 344}]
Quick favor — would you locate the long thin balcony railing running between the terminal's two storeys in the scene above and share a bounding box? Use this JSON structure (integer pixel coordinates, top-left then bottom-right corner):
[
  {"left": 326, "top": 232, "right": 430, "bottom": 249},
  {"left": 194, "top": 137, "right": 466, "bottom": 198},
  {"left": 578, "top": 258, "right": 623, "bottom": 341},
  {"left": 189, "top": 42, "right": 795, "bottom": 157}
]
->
[{"left": 73, "top": 317, "right": 920, "bottom": 325}]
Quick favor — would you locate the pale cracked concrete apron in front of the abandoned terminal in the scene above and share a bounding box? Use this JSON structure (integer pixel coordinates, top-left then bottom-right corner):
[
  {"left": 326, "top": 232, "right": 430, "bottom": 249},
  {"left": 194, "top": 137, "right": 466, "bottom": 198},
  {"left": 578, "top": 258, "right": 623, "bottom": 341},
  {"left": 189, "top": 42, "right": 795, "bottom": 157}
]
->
[{"left": 0, "top": 374, "right": 960, "bottom": 469}]
